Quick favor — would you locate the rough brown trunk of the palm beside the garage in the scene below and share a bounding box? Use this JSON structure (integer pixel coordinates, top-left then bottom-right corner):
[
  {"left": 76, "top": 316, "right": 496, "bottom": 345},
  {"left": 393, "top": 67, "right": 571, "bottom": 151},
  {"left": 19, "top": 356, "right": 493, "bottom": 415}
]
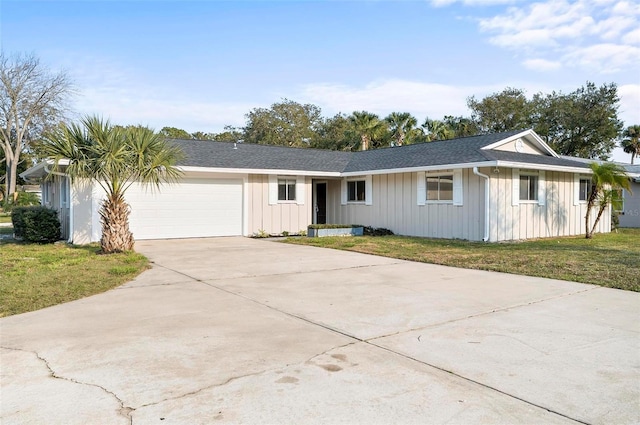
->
[{"left": 100, "top": 194, "right": 134, "bottom": 254}]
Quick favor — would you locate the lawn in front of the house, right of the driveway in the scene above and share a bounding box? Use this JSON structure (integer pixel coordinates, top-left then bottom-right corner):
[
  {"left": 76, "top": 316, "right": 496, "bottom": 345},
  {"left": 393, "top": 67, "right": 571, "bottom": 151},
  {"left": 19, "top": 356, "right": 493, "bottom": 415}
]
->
[{"left": 285, "top": 229, "right": 640, "bottom": 292}]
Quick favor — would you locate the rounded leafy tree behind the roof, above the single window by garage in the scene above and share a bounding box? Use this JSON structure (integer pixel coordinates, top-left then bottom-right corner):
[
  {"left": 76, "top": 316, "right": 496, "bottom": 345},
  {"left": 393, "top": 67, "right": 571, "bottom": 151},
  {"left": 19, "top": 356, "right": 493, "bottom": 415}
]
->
[{"left": 243, "top": 99, "right": 322, "bottom": 147}]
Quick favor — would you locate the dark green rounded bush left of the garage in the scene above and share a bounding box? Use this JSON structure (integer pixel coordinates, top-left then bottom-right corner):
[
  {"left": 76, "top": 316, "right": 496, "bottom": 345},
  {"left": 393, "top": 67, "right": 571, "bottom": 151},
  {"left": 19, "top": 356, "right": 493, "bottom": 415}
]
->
[{"left": 11, "top": 207, "right": 60, "bottom": 243}]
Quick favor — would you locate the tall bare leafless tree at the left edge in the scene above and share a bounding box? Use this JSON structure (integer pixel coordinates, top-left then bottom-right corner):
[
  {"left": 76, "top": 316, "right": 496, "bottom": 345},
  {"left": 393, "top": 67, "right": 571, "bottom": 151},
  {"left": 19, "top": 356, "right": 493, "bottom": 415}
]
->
[{"left": 0, "top": 52, "right": 73, "bottom": 204}]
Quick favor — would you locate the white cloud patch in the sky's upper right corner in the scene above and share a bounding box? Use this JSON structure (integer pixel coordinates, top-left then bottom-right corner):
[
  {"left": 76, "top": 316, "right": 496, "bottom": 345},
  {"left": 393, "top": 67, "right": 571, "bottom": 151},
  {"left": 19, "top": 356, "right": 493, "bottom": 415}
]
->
[{"left": 478, "top": 0, "right": 640, "bottom": 74}]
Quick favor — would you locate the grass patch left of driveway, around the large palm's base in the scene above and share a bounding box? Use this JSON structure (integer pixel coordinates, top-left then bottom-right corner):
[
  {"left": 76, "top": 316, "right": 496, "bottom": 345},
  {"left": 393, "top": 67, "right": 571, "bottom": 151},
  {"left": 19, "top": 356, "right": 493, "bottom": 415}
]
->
[{"left": 0, "top": 237, "right": 148, "bottom": 317}]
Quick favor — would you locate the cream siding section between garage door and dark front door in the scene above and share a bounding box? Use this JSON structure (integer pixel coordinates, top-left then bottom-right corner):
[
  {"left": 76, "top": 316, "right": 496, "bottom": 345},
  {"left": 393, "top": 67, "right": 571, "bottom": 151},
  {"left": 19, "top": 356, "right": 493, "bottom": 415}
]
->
[{"left": 248, "top": 174, "right": 313, "bottom": 235}]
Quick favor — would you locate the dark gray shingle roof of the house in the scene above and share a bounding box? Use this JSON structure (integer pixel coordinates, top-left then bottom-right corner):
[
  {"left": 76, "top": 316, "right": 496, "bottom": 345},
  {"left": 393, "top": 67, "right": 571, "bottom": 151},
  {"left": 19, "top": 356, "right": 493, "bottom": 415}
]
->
[{"left": 171, "top": 131, "right": 588, "bottom": 173}]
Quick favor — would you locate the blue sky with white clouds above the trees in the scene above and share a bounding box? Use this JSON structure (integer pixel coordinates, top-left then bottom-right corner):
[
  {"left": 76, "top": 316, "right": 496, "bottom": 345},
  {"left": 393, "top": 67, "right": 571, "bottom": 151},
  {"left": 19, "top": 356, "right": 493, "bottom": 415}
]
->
[{"left": 0, "top": 0, "right": 640, "bottom": 161}]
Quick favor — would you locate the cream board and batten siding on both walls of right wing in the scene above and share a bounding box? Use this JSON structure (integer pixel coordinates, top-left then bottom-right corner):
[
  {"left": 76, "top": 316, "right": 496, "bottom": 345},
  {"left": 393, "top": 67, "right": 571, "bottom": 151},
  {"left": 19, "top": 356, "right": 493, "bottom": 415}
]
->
[{"left": 327, "top": 168, "right": 611, "bottom": 242}]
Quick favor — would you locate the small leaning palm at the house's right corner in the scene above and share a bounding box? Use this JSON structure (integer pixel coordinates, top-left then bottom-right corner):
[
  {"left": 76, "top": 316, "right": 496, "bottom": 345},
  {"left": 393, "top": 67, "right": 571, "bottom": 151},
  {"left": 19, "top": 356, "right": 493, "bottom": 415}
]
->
[{"left": 585, "top": 162, "right": 631, "bottom": 239}]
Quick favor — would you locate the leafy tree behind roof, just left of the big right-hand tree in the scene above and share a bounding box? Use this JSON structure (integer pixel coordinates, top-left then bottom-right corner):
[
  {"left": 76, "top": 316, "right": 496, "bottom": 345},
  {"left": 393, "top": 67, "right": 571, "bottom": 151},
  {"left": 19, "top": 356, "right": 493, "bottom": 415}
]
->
[{"left": 467, "top": 87, "right": 532, "bottom": 133}]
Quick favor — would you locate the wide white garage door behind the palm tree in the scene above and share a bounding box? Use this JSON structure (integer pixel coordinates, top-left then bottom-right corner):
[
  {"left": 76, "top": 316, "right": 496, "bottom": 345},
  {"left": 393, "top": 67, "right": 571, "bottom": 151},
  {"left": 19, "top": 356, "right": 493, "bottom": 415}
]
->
[{"left": 126, "top": 179, "right": 242, "bottom": 240}]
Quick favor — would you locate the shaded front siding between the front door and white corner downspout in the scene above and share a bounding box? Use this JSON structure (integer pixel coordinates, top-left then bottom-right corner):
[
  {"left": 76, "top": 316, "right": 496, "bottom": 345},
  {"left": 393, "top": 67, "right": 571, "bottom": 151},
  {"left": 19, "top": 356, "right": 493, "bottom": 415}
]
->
[{"left": 327, "top": 170, "right": 484, "bottom": 240}]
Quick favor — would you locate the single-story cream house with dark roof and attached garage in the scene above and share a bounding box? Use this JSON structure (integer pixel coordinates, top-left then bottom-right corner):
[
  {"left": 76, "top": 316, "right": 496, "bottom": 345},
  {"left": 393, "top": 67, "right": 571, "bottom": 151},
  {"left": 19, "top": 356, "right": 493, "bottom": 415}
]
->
[{"left": 22, "top": 130, "right": 611, "bottom": 244}]
